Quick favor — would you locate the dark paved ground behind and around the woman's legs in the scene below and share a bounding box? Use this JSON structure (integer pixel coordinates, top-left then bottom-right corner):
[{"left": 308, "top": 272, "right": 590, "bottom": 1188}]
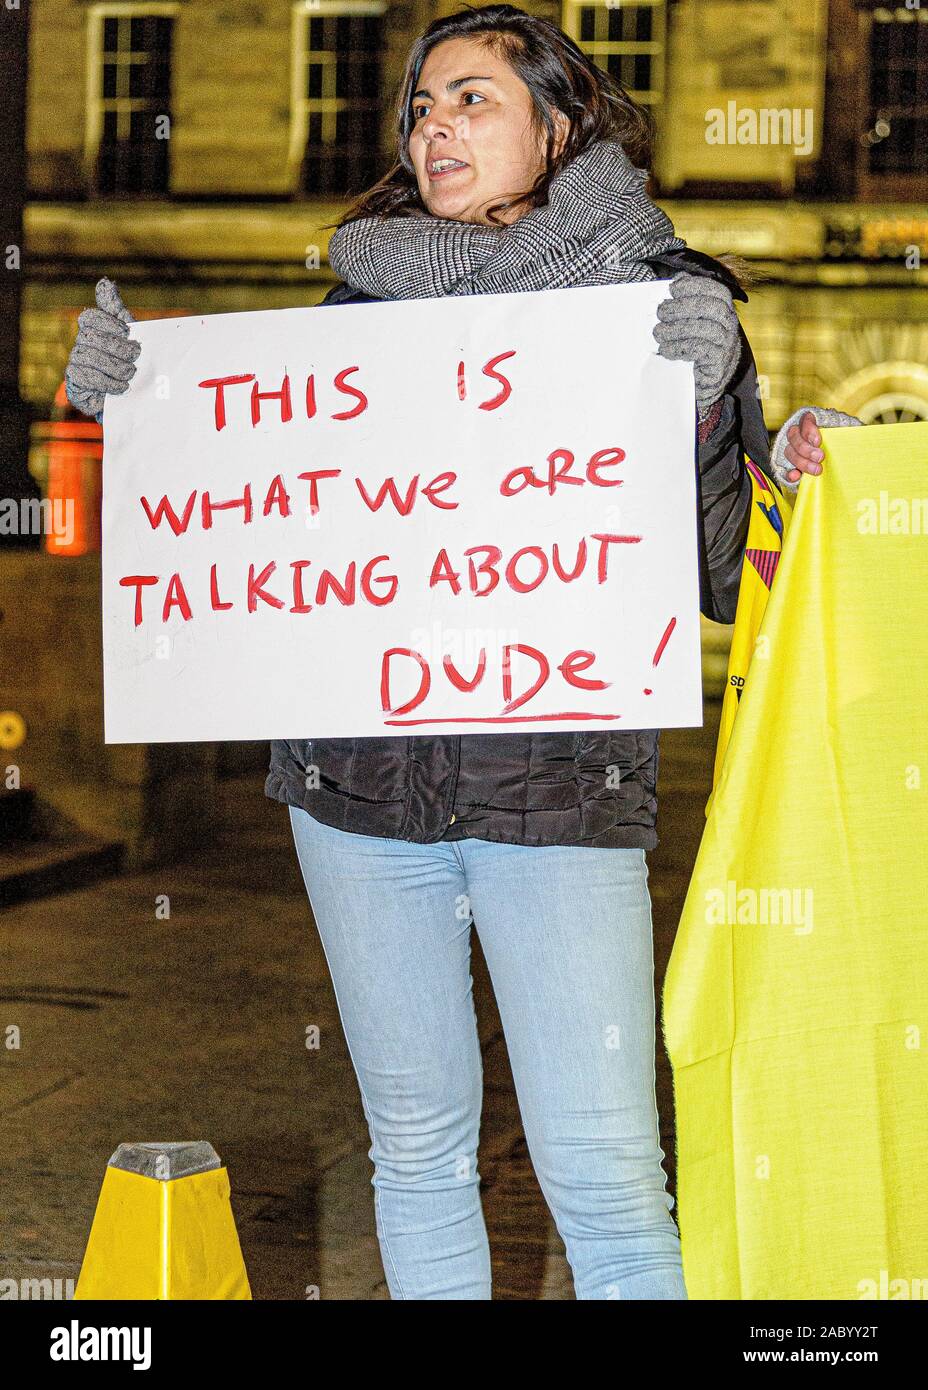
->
[{"left": 0, "top": 703, "right": 718, "bottom": 1300}]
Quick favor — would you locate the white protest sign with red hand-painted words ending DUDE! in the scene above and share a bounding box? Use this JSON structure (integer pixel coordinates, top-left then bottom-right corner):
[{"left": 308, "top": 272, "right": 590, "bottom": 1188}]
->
[{"left": 103, "top": 282, "right": 702, "bottom": 744}]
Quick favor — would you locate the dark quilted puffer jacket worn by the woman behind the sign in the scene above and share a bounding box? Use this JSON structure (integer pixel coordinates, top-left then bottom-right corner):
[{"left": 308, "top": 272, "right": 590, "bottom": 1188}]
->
[{"left": 265, "top": 249, "right": 770, "bottom": 849}]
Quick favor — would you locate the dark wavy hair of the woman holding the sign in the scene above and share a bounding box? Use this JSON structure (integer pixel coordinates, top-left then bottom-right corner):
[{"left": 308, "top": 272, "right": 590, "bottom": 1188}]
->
[{"left": 332, "top": 4, "right": 653, "bottom": 227}]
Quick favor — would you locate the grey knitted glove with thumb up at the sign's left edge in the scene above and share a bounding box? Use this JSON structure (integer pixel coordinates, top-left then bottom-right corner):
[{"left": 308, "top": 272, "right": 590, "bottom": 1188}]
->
[{"left": 64, "top": 277, "right": 142, "bottom": 424}]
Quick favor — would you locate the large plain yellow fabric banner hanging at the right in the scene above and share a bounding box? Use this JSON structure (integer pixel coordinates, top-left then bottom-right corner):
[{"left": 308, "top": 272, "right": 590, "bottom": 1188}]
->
[{"left": 663, "top": 424, "right": 928, "bottom": 1300}]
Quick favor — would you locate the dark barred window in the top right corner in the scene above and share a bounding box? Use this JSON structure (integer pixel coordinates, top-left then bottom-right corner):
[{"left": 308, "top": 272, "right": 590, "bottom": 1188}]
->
[{"left": 867, "top": 7, "right": 928, "bottom": 175}]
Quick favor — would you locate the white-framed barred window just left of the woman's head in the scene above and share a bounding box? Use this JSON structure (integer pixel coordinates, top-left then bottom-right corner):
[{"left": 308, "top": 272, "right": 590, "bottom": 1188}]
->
[{"left": 293, "top": 0, "right": 386, "bottom": 196}]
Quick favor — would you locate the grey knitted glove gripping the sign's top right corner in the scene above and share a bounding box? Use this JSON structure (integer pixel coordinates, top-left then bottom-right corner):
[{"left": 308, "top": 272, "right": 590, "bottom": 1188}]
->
[{"left": 654, "top": 271, "right": 740, "bottom": 420}]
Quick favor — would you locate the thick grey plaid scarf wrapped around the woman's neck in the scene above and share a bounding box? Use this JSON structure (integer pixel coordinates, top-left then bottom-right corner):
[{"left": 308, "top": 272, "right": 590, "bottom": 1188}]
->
[{"left": 329, "top": 140, "right": 686, "bottom": 299}]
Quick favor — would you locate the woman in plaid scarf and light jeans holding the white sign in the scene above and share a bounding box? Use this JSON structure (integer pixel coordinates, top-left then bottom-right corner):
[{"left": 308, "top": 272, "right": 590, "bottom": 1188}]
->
[{"left": 68, "top": 6, "right": 861, "bottom": 1300}]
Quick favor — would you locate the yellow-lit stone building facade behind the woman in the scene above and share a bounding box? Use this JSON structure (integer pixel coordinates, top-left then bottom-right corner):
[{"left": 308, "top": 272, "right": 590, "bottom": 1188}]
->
[{"left": 22, "top": 0, "right": 928, "bottom": 427}]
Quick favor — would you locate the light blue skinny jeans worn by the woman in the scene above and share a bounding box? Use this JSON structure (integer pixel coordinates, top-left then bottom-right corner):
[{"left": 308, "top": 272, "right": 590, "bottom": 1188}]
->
[{"left": 290, "top": 808, "right": 686, "bottom": 1300}]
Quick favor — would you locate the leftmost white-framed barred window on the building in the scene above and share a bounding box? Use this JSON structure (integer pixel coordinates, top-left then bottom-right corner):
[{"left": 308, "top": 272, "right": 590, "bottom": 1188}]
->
[{"left": 88, "top": 4, "right": 176, "bottom": 193}]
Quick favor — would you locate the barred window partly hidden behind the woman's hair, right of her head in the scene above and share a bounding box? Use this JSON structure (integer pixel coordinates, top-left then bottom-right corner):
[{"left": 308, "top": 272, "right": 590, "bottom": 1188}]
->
[{"left": 561, "top": 0, "right": 667, "bottom": 106}]
